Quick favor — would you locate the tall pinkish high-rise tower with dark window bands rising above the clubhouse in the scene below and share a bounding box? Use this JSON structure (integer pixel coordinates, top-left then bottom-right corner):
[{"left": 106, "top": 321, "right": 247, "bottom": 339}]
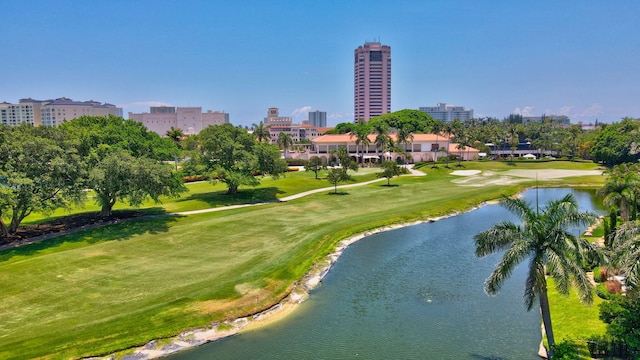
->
[{"left": 353, "top": 42, "right": 391, "bottom": 122}]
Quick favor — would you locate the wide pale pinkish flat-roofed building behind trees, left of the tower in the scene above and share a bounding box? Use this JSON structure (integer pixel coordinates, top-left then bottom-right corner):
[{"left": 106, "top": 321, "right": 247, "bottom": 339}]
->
[{"left": 129, "top": 106, "right": 229, "bottom": 136}]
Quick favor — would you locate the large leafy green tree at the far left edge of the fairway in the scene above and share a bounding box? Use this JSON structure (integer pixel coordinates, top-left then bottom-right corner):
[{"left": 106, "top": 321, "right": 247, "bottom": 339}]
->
[{"left": 0, "top": 125, "right": 85, "bottom": 236}]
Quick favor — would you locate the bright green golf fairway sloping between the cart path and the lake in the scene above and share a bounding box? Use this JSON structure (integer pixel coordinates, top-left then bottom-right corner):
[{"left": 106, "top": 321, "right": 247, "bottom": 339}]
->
[{"left": 0, "top": 163, "right": 604, "bottom": 358}]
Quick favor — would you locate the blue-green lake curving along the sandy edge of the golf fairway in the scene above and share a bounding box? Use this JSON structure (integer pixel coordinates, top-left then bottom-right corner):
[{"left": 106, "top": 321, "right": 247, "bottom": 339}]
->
[{"left": 169, "top": 189, "right": 597, "bottom": 360}]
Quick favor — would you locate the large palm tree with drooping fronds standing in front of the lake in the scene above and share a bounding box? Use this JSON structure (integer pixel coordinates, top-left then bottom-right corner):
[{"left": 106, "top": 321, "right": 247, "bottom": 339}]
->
[{"left": 474, "top": 194, "right": 595, "bottom": 358}]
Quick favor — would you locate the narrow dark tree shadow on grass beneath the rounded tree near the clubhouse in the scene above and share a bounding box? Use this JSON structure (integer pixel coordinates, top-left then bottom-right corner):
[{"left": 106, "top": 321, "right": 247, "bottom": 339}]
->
[{"left": 175, "top": 187, "right": 285, "bottom": 208}]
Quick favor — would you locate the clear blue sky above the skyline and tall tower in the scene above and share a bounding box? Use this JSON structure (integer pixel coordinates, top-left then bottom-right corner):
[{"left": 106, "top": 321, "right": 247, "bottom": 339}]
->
[{"left": 0, "top": 0, "right": 640, "bottom": 125}]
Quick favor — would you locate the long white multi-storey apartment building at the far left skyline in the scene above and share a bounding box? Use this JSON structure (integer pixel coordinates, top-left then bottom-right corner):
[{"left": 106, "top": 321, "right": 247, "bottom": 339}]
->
[{"left": 0, "top": 97, "right": 122, "bottom": 126}]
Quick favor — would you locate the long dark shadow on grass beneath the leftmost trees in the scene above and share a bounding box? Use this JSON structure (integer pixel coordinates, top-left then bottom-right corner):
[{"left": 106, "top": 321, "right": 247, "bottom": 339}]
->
[{"left": 0, "top": 208, "right": 182, "bottom": 262}]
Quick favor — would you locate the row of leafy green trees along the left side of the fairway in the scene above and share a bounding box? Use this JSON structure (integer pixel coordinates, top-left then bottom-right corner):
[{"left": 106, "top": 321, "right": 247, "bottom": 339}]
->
[{"left": 0, "top": 116, "right": 287, "bottom": 239}]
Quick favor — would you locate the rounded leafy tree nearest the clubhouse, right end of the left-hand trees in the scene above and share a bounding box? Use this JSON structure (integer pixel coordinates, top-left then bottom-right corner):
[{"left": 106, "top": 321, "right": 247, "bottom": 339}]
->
[{"left": 198, "top": 124, "right": 286, "bottom": 194}]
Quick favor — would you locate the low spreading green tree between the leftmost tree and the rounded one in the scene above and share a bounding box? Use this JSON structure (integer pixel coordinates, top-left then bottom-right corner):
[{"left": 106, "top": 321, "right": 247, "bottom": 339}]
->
[{"left": 88, "top": 150, "right": 187, "bottom": 217}]
